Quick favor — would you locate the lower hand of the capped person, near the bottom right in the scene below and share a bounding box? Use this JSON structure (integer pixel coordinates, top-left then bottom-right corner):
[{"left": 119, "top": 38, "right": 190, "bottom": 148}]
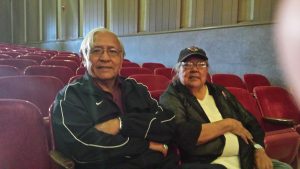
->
[{"left": 255, "top": 149, "right": 273, "bottom": 169}]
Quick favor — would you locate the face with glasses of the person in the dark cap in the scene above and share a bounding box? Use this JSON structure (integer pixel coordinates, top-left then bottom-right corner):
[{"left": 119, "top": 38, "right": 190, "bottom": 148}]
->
[{"left": 178, "top": 57, "right": 208, "bottom": 88}]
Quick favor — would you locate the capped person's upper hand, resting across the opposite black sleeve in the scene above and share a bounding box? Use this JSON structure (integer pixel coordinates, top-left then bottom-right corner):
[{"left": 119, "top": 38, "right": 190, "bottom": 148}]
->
[{"left": 224, "top": 118, "right": 253, "bottom": 144}]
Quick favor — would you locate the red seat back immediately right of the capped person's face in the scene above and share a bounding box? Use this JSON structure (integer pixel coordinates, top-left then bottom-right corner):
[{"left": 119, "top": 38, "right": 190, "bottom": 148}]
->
[{"left": 211, "top": 73, "right": 246, "bottom": 89}]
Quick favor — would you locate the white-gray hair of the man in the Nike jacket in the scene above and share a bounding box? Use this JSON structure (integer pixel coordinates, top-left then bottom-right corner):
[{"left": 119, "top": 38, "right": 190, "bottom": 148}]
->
[{"left": 79, "top": 28, "right": 125, "bottom": 66}]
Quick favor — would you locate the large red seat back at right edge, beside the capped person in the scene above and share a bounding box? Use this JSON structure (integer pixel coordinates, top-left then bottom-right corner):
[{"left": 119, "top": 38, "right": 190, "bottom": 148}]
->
[{"left": 254, "top": 86, "right": 300, "bottom": 130}]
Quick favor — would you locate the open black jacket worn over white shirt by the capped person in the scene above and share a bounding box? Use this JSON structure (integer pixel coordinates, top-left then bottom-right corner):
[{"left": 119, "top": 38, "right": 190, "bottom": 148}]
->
[{"left": 160, "top": 80, "right": 264, "bottom": 169}]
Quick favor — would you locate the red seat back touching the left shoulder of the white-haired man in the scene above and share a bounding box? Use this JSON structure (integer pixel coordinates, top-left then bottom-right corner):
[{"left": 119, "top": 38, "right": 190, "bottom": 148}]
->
[{"left": 24, "top": 65, "right": 75, "bottom": 84}]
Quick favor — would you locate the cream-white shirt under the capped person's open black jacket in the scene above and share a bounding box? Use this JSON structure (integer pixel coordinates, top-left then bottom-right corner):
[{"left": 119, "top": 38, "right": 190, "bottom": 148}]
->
[{"left": 198, "top": 87, "right": 241, "bottom": 169}]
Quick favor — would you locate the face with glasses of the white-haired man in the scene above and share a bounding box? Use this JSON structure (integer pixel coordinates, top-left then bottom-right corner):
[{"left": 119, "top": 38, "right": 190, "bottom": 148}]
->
[{"left": 87, "top": 32, "right": 123, "bottom": 80}]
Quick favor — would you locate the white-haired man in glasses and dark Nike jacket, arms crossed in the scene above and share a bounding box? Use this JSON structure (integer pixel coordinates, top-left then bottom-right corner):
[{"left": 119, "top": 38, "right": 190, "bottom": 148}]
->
[{"left": 52, "top": 28, "right": 178, "bottom": 169}]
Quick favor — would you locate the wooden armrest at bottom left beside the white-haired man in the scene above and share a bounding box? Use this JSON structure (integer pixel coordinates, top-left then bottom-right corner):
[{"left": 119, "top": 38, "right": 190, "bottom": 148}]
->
[{"left": 49, "top": 150, "right": 75, "bottom": 169}]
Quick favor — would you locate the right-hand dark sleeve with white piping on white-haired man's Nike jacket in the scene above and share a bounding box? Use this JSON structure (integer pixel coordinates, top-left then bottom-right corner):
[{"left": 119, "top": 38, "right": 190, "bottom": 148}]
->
[{"left": 121, "top": 84, "right": 175, "bottom": 143}]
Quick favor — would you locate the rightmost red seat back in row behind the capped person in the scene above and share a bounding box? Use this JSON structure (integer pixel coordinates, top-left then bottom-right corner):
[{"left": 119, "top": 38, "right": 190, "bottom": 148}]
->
[{"left": 243, "top": 73, "right": 271, "bottom": 93}]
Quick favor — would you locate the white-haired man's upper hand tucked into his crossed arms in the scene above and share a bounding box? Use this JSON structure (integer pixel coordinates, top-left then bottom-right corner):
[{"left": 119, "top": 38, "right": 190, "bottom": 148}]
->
[{"left": 95, "top": 118, "right": 120, "bottom": 135}]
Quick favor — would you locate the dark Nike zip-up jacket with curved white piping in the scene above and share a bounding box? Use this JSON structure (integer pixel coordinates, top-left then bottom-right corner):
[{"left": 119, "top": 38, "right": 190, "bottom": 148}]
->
[{"left": 52, "top": 74, "right": 176, "bottom": 169}]
